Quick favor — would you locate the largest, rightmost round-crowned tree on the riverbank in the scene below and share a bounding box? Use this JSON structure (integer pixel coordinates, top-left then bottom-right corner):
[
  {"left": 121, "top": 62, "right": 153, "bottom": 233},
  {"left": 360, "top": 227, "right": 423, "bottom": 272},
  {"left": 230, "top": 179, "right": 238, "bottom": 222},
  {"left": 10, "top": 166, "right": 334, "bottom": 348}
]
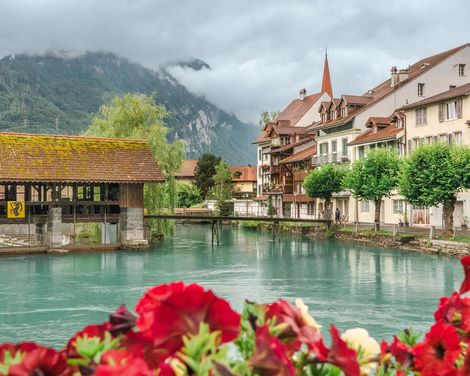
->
[{"left": 399, "top": 143, "right": 470, "bottom": 236}]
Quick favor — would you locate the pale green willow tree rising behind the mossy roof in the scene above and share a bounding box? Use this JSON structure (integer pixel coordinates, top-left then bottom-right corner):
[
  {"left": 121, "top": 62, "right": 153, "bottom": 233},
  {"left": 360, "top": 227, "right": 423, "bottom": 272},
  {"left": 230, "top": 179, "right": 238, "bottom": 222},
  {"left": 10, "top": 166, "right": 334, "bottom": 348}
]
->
[{"left": 84, "top": 93, "right": 183, "bottom": 233}]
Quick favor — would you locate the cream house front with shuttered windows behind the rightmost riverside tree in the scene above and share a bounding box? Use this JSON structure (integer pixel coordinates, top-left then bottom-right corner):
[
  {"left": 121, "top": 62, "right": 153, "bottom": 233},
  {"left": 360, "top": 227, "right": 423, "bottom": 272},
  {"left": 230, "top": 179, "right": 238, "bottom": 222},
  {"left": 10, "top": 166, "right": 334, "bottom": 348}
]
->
[{"left": 401, "top": 82, "right": 470, "bottom": 227}]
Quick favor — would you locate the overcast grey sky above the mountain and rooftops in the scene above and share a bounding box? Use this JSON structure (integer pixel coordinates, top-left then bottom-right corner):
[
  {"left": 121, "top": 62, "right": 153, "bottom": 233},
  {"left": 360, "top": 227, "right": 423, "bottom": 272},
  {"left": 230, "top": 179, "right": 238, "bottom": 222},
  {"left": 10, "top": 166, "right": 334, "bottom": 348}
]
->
[{"left": 0, "top": 0, "right": 470, "bottom": 122}]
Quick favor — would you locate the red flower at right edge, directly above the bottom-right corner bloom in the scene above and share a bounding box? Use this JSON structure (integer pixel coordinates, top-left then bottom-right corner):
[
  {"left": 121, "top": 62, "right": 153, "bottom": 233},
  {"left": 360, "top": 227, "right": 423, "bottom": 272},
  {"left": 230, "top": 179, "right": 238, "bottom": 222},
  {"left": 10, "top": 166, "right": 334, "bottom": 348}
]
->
[{"left": 434, "top": 292, "right": 470, "bottom": 333}]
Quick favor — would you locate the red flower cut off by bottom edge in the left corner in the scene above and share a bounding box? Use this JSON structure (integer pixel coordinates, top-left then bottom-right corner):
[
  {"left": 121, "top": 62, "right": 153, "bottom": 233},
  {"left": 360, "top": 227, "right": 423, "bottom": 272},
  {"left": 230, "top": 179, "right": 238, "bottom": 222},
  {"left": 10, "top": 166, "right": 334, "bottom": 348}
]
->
[{"left": 9, "top": 347, "right": 72, "bottom": 376}]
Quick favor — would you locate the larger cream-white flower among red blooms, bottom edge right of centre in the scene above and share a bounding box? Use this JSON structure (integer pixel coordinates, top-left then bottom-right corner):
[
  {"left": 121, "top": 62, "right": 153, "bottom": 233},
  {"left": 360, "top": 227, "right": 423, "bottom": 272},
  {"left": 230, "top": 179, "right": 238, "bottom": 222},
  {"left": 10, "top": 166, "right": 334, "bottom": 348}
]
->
[{"left": 341, "top": 328, "right": 380, "bottom": 375}]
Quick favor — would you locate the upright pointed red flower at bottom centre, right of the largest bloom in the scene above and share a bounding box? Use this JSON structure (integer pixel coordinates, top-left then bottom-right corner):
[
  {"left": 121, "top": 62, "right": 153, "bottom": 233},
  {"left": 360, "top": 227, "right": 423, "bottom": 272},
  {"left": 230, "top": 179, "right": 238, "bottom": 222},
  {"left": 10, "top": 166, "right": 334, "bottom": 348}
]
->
[{"left": 249, "top": 325, "right": 295, "bottom": 376}]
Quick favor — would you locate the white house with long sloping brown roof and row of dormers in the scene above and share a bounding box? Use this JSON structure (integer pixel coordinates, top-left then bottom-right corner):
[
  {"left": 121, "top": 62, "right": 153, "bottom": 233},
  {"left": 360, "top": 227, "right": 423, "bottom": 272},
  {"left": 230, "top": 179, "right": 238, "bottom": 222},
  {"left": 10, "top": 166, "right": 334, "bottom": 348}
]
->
[{"left": 306, "top": 43, "right": 470, "bottom": 222}]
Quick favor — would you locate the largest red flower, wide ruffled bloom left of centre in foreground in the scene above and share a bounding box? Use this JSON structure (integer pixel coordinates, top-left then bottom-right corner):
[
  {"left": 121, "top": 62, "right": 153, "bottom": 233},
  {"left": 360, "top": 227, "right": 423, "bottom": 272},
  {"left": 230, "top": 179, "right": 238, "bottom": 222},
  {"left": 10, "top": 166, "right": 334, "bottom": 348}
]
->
[{"left": 136, "top": 282, "right": 240, "bottom": 354}]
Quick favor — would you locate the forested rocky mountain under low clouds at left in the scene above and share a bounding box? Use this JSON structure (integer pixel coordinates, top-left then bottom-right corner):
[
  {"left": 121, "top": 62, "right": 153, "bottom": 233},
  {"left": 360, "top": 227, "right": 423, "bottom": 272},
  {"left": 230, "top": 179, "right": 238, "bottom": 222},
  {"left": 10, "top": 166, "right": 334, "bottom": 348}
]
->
[{"left": 0, "top": 52, "right": 258, "bottom": 164}]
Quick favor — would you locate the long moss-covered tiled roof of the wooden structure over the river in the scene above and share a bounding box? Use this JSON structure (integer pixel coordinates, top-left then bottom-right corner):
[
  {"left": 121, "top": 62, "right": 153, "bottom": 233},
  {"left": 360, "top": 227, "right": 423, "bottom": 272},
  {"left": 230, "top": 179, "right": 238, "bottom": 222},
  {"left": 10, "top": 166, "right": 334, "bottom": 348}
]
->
[{"left": 0, "top": 133, "right": 165, "bottom": 183}]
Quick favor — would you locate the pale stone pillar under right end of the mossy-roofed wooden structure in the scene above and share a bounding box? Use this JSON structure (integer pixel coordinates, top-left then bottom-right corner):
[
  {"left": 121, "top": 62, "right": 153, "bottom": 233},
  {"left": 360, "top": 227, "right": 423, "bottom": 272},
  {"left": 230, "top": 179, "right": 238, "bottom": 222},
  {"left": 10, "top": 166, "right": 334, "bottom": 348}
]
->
[{"left": 120, "top": 207, "right": 148, "bottom": 247}]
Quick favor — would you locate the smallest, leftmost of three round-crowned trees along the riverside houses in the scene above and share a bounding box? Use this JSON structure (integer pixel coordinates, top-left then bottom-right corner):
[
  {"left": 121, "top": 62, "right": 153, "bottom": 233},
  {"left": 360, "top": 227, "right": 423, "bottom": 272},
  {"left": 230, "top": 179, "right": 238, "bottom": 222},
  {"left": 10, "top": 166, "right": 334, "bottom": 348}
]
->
[{"left": 304, "top": 163, "right": 344, "bottom": 219}]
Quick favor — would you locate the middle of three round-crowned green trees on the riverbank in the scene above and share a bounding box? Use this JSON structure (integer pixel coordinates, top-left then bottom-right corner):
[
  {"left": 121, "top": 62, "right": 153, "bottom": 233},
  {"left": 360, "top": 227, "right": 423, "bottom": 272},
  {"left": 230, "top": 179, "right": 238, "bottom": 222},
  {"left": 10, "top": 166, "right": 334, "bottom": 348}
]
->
[{"left": 343, "top": 148, "right": 401, "bottom": 230}]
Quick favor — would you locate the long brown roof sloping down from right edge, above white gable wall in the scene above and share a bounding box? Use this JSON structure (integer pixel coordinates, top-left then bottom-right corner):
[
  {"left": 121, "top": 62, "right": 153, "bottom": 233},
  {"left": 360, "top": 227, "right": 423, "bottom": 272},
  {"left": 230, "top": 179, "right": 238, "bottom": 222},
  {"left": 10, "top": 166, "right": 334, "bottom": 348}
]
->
[{"left": 309, "top": 43, "right": 470, "bottom": 130}]
